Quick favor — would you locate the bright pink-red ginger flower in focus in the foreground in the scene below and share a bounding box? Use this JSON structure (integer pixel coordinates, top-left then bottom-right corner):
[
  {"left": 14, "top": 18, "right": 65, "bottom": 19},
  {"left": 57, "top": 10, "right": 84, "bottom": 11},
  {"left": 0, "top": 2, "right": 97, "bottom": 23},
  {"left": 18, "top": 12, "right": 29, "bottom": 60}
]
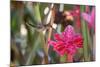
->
[{"left": 49, "top": 25, "right": 83, "bottom": 56}]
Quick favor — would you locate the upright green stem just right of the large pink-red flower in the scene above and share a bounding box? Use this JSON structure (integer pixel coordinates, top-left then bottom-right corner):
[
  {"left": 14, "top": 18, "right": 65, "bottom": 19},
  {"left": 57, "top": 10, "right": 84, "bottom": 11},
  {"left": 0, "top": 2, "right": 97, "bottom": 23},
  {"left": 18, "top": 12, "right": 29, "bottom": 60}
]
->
[{"left": 81, "top": 6, "right": 89, "bottom": 61}]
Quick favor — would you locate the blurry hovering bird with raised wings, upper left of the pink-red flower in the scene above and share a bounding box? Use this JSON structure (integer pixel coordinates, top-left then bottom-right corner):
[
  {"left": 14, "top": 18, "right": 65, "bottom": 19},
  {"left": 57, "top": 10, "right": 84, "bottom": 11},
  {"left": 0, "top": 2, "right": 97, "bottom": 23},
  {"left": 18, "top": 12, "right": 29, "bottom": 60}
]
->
[{"left": 24, "top": 4, "right": 54, "bottom": 31}]
